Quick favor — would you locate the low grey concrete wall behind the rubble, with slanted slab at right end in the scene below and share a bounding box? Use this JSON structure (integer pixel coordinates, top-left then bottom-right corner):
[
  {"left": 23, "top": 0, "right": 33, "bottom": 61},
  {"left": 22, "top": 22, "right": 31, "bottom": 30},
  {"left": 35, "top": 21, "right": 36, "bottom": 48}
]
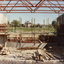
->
[{"left": 7, "top": 42, "right": 47, "bottom": 48}]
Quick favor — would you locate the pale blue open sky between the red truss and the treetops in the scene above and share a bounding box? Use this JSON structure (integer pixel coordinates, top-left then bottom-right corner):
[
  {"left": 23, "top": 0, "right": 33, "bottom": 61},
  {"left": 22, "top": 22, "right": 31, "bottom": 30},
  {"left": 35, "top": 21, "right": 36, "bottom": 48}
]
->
[{"left": 4, "top": 13, "right": 58, "bottom": 24}]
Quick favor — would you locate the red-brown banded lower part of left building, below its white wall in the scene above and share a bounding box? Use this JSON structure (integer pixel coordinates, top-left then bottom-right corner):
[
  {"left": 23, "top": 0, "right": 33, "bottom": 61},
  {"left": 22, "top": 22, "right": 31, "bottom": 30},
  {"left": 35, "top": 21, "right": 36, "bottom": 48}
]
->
[{"left": 0, "top": 24, "right": 7, "bottom": 44}]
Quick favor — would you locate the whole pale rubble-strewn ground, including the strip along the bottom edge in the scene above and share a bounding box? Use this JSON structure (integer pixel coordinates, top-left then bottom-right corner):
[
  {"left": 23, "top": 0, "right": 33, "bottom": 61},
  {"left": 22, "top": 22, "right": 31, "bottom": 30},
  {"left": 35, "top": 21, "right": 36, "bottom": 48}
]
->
[{"left": 0, "top": 47, "right": 61, "bottom": 64}]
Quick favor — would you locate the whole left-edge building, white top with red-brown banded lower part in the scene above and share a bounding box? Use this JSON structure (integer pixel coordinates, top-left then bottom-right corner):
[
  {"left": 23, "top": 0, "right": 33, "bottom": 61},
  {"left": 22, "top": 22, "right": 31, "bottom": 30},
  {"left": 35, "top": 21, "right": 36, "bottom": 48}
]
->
[{"left": 0, "top": 14, "right": 7, "bottom": 44}]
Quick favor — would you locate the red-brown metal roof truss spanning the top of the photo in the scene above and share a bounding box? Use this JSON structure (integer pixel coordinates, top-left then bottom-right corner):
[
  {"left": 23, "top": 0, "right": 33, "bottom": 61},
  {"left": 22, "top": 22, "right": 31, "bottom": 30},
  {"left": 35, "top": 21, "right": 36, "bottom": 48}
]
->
[{"left": 0, "top": 0, "right": 64, "bottom": 14}]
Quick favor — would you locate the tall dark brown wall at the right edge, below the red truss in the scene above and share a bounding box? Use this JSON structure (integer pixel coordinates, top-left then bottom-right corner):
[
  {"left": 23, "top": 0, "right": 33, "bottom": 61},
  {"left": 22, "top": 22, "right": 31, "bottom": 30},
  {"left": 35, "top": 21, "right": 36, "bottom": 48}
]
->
[{"left": 57, "top": 14, "right": 64, "bottom": 46}]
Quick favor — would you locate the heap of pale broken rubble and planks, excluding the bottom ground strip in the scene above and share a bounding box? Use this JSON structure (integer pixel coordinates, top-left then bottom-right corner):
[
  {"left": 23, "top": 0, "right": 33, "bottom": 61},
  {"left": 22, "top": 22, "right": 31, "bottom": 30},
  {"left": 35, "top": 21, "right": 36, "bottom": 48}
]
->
[{"left": 0, "top": 47, "right": 57, "bottom": 62}]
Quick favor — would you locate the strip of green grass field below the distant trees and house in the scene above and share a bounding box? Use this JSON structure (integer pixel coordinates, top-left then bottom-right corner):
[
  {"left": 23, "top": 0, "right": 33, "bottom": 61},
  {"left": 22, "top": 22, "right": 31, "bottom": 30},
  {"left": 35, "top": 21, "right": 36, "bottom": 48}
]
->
[{"left": 8, "top": 27, "right": 55, "bottom": 32}]
